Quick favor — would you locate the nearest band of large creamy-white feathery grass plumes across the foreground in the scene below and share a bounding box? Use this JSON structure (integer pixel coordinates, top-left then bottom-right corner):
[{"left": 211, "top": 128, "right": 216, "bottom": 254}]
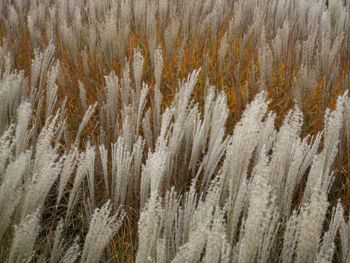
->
[{"left": 0, "top": 65, "right": 348, "bottom": 262}]
